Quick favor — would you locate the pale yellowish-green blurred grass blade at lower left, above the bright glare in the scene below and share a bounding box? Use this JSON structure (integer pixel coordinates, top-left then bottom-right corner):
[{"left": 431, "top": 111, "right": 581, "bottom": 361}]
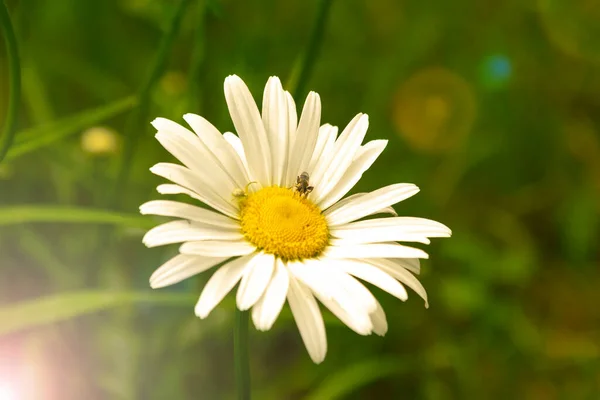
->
[{"left": 0, "top": 290, "right": 196, "bottom": 335}]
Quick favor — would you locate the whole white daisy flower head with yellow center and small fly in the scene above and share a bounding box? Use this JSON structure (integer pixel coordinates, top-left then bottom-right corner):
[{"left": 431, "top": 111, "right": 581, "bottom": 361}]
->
[{"left": 140, "top": 75, "right": 451, "bottom": 363}]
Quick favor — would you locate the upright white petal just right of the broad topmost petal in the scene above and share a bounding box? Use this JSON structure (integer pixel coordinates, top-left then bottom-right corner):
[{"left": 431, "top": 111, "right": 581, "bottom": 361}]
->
[{"left": 262, "top": 76, "right": 289, "bottom": 185}]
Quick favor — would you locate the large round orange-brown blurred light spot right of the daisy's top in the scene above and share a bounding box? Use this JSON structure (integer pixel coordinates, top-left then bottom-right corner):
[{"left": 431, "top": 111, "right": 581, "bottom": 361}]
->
[{"left": 392, "top": 68, "right": 476, "bottom": 152}]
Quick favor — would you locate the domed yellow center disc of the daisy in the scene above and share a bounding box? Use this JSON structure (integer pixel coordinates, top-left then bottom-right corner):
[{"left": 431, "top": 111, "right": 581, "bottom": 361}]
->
[{"left": 240, "top": 186, "right": 329, "bottom": 260}]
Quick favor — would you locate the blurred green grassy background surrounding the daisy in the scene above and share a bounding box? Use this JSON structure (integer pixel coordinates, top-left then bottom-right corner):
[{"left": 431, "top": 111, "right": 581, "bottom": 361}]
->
[{"left": 0, "top": 0, "right": 600, "bottom": 400}]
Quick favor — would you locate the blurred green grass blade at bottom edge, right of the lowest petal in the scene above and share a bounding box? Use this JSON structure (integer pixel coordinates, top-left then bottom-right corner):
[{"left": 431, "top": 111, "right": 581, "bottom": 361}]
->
[{"left": 306, "top": 357, "right": 409, "bottom": 400}]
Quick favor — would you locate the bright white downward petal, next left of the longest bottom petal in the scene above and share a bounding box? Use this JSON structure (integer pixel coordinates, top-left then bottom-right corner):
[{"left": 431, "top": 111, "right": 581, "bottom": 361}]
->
[{"left": 252, "top": 259, "right": 290, "bottom": 331}]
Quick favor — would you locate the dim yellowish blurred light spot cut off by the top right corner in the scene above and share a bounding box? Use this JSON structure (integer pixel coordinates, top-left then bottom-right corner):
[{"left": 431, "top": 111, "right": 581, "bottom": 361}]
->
[{"left": 537, "top": 0, "right": 600, "bottom": 64}]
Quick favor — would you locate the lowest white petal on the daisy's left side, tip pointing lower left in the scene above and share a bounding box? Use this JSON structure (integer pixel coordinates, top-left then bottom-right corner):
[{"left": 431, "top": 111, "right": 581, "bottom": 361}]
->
[{"left": 150, "top": 254, "right": 227, "bottom": 289}]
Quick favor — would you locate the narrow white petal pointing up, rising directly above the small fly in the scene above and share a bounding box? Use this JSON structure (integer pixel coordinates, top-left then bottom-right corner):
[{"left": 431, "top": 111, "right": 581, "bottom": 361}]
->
[{"left": 285, "top": 92, "right": 321, "bottom": 186}]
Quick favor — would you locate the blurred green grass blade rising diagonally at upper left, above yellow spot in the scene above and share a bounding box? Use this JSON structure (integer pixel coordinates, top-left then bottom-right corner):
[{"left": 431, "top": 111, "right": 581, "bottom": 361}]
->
[{"left": 6, "top": 96, "right": 136, "bottom": 160}]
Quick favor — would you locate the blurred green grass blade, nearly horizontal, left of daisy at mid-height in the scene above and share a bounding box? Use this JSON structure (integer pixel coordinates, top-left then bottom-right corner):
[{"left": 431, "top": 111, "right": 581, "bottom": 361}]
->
[{"left": 0, "top": 205, "right": 155, "bottom": 229}]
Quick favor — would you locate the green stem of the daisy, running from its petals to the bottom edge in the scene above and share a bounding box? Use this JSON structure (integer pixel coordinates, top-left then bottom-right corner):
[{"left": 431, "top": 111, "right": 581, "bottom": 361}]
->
[{"left": 233, "top": 308, "right": 250, "bottom": 400}]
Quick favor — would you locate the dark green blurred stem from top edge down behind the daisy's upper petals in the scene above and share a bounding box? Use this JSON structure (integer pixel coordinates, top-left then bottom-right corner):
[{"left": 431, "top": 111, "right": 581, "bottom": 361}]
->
[{"left": 290, "top": 0, "right": 333, "bottom": 103}]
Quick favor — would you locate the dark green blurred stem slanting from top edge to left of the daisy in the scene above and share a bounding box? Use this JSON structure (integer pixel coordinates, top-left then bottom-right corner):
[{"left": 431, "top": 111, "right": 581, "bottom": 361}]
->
[{"left": 111, "top": 0, "right": 190, "bottom": 206}]
